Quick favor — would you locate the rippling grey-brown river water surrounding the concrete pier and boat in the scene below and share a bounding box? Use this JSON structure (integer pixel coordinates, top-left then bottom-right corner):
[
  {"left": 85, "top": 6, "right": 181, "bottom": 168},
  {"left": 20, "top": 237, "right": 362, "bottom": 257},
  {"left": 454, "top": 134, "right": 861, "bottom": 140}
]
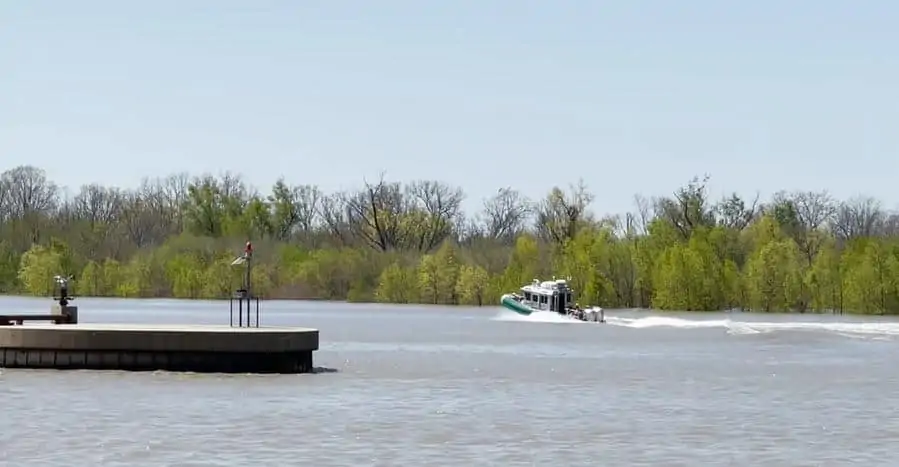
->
[{"left": 0, "top": 297, "right": 899, "bottom": 467}]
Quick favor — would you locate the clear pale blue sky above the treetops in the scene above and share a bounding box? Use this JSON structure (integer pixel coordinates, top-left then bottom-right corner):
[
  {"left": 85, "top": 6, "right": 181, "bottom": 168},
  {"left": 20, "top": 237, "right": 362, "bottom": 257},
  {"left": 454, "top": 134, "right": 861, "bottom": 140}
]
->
[{"left": 0, "top": 0, "right": 899, "bottom": 217}]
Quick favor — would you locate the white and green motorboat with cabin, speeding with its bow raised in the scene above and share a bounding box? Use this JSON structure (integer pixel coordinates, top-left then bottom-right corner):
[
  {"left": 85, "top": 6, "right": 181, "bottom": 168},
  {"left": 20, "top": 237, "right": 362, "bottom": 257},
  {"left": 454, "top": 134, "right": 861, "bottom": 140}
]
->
[{"left": 500, "top": 279, "right": 606, "bottom": 323}]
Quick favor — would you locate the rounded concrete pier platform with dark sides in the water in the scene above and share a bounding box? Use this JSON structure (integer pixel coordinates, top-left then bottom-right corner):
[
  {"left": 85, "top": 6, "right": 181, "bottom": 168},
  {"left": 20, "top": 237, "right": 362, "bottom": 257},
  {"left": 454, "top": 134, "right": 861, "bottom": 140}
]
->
[{"left": 0, "top": 324, "right": 318, "bottom": 373}]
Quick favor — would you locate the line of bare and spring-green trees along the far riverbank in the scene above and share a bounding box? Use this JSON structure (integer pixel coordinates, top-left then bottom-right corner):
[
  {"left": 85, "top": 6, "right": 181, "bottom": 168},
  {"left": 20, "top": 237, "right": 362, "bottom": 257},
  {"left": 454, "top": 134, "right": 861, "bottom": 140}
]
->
[{"left": 0, "top": 166, "right": 899, "bottom": 314}]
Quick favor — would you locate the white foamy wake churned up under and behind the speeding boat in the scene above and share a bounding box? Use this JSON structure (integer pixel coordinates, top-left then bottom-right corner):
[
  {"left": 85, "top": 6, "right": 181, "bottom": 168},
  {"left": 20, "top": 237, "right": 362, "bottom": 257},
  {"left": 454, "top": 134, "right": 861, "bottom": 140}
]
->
[{"left": 494, "top": 313, "right": 899, "bottom": 340}]
